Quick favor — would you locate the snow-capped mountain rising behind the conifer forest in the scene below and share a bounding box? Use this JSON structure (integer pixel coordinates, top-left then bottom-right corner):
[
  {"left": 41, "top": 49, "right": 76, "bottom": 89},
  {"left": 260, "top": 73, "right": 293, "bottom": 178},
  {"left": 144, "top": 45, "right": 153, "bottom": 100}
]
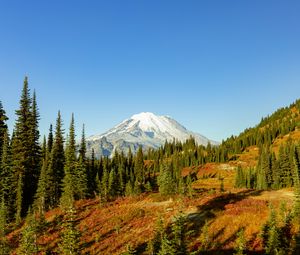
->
[{"left": 87, "top": 112, "right": 218, "bottom": 157}]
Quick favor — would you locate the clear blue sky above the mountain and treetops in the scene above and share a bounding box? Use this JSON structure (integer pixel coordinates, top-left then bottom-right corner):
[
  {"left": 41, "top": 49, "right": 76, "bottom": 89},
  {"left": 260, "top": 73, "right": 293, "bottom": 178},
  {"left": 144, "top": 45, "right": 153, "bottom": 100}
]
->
[{"left": 0, "top": 0, "right": 300, "bottom": 141}]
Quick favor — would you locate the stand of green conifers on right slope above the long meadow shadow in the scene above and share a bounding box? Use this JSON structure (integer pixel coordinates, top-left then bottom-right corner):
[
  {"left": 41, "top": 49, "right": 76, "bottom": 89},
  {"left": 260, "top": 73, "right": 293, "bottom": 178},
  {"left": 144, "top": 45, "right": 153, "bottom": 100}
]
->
[{"left": 235, "top": 141, "right": 300, "bottom": 189}]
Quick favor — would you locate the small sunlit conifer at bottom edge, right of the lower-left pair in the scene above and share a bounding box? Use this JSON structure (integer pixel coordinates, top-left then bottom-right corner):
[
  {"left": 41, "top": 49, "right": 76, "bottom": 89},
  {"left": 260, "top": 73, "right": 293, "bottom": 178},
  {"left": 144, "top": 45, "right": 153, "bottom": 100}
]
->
[{"left": 59, "top": 207, "right": 80, "bottom": 255}]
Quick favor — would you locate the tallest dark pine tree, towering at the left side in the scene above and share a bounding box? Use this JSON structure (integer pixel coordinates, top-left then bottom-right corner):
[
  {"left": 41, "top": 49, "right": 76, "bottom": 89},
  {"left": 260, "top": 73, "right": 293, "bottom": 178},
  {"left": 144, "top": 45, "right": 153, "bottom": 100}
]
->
[{"left": 12, "top": 77, "right": 40, "bottom": 215}]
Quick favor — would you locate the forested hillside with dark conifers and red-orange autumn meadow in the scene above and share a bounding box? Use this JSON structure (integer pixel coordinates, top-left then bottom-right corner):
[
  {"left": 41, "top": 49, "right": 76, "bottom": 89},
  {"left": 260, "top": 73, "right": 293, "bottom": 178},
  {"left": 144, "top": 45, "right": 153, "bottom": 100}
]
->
[{"left": 0, "top": 78, "right": 300, "bottom": 254}]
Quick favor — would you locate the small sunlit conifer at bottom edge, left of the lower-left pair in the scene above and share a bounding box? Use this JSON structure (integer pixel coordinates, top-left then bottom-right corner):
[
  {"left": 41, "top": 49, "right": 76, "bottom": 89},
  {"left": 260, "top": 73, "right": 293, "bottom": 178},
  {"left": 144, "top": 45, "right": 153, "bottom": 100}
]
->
[{"left": 17, "top": 209, "right": 39, "bottom": 255}]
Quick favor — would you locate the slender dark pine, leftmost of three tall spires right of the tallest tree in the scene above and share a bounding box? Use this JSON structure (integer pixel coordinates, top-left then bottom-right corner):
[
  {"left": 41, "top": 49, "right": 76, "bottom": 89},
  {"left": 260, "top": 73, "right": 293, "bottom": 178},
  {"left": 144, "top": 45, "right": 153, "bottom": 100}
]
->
[{"left": 48, "top": 112, "right": 65, "bottom": 207}]
